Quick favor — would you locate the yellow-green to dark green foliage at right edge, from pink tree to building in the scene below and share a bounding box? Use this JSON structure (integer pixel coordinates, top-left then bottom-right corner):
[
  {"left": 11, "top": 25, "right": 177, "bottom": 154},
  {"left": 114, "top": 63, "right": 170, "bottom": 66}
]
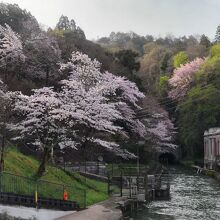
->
[{"left": 178, "top": 44, "right": 220, "bottom": 156}]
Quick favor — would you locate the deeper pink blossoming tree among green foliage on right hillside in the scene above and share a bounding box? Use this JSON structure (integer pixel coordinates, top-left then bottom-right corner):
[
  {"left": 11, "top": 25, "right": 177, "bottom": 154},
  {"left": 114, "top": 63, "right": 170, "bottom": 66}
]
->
[{"left": 168, "top": 58, "right": 205, "bottom": 101}]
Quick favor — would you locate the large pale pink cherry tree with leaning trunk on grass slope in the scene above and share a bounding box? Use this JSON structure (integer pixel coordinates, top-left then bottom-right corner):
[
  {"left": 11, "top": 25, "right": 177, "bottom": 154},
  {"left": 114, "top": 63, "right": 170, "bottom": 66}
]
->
[{"left": 11, "top": 52, "right": 145, "bottom": 176}]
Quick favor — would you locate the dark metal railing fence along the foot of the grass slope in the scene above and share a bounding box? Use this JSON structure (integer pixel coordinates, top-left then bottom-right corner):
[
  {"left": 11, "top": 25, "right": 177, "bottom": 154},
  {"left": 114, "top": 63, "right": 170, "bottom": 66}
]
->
[{"left": 0, "top": 172, "right": 86, "bottom": 208}]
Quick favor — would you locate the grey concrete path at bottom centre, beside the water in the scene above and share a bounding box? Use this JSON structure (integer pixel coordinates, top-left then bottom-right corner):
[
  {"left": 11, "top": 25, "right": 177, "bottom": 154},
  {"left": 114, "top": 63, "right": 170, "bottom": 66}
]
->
[{"left": 57, "top": 197, "right": 123, "bottom": 220}]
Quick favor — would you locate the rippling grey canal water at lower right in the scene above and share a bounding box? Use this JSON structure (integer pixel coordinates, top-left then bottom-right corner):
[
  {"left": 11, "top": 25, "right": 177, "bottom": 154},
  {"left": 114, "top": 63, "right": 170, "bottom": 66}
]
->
[{"left": 133, "top": 168, "right": 220, "bottom": 220}]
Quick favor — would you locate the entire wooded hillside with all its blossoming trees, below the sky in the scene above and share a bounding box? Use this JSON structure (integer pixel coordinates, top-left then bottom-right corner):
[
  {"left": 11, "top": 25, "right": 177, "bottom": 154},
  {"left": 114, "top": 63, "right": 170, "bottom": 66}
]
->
[{"left": 0, "top": 3, "right": 220, "bottom": 175}]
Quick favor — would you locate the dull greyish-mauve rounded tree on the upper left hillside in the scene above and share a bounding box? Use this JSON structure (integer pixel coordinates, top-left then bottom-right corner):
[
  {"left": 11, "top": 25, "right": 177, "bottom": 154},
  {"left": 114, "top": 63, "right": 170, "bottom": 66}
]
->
[{"left": 24, "top": 31, "right": 61, "bottom": 86}]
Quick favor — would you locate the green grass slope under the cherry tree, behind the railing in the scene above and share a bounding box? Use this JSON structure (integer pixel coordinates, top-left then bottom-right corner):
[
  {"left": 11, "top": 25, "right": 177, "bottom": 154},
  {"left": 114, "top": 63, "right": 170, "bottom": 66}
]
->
[{"left": 2, "top": 148, "right": 108, "bottom": 207}]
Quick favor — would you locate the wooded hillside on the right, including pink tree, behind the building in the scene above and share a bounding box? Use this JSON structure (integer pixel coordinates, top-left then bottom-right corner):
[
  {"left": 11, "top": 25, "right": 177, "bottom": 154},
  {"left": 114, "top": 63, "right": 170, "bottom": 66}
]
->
[{"left": 97, "top": 27, "right": 220, "bottom": 160}]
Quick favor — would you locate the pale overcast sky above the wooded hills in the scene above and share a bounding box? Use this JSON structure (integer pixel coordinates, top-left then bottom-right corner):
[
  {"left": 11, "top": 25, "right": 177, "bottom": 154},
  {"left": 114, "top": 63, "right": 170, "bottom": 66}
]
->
[{"left": 3, "top": 0, "right": 220, "bottom": 39}]
